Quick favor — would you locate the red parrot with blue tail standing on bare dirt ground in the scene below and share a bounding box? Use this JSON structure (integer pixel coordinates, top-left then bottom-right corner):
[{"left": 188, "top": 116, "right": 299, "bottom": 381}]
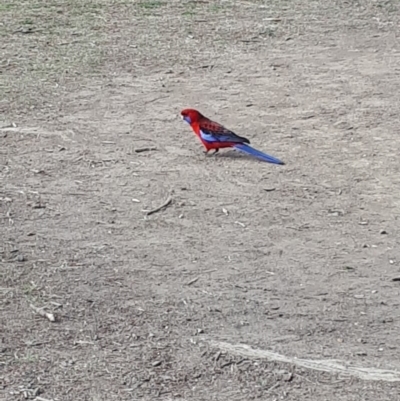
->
[{"left": 181, "top": 109, "right": 285, "bottom": 164}]
